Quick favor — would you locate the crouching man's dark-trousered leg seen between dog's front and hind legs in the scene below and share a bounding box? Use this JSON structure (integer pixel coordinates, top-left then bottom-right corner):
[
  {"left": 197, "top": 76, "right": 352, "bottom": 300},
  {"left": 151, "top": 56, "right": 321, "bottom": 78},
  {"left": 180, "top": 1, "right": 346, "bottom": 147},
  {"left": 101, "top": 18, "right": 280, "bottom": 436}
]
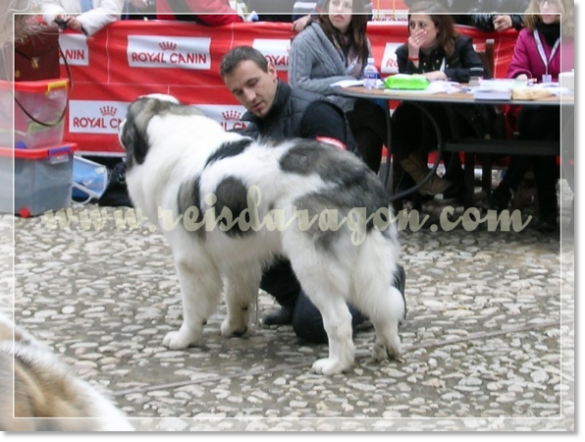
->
[{"left": 260, "top": 259, "right": 301, "bottom": 325}]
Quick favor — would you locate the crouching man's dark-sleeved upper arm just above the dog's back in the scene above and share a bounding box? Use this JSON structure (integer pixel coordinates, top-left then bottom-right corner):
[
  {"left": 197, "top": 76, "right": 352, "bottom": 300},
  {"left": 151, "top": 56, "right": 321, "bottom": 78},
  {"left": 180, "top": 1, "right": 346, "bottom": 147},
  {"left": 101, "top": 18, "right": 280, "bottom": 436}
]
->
[{"left": 301, "top": 101, "right": 356, "bottom": 152}]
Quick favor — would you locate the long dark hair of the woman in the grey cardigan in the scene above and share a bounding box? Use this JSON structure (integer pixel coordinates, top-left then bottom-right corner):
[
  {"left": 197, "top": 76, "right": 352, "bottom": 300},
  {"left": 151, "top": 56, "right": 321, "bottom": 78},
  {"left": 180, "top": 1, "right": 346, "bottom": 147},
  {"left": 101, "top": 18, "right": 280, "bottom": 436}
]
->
[{"left": 307, "top": 0, "right": 370, "bottom": 66}]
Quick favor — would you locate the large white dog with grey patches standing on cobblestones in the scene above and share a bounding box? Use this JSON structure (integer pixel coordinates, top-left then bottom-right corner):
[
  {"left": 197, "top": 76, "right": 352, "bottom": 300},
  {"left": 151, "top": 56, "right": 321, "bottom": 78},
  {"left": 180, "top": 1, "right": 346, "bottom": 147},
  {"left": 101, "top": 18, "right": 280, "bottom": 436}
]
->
[{"left": 120, "top": 94, "right": 405, "bottom": 374}]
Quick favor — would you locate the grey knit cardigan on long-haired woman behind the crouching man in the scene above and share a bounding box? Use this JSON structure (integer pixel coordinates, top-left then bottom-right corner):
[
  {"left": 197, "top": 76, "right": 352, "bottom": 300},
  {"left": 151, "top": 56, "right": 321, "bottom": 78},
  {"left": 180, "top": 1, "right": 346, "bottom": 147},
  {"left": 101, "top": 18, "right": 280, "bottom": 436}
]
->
[{"left": 288, "top": 22, "right": 370, "bottom": 112}]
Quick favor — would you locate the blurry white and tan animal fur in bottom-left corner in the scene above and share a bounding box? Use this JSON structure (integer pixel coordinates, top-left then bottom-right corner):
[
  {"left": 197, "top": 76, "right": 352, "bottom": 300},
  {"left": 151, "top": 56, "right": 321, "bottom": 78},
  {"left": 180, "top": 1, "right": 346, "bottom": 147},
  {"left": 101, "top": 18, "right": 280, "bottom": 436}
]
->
[{"left": 0, "top": 313, "right": 134, "bottom": 431}]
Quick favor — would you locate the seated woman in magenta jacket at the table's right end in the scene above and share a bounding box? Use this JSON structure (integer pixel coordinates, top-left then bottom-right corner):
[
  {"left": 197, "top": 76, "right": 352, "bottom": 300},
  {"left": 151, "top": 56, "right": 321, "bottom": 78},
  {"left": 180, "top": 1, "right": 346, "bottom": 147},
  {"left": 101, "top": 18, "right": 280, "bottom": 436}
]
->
[{"left": 490, "top": 0, "right": 573, "bottom": 232}]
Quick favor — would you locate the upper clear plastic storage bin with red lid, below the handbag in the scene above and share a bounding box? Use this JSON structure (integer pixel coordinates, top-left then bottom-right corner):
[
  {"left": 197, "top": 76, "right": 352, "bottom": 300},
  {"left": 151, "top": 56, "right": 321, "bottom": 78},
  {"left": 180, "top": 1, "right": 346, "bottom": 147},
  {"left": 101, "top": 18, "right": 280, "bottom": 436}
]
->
[{"left": 0, "top": 79, "right": 69, "bottom": 149}]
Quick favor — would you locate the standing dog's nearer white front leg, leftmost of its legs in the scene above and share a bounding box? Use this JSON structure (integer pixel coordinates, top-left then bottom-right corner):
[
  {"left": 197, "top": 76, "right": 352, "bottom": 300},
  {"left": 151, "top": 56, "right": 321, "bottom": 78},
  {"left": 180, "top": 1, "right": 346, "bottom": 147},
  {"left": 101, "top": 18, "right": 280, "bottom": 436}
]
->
[{"left": 163, "top": 259, "right": 222, "bottom": 349}]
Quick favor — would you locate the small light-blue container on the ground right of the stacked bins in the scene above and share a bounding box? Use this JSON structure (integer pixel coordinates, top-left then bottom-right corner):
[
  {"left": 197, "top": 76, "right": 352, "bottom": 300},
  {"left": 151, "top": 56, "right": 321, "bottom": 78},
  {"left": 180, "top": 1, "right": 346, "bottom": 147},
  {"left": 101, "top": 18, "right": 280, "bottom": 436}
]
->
[{"left": 72, "top": 156, "right": 108, "bottom": 203}]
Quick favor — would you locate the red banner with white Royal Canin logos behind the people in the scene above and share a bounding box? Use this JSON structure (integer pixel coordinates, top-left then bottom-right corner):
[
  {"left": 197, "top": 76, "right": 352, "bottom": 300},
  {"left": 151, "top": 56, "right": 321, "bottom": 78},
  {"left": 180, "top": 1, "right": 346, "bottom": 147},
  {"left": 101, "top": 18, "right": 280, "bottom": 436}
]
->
[{"left": 60, "top": 20, "right": 517, "bottom": 155}]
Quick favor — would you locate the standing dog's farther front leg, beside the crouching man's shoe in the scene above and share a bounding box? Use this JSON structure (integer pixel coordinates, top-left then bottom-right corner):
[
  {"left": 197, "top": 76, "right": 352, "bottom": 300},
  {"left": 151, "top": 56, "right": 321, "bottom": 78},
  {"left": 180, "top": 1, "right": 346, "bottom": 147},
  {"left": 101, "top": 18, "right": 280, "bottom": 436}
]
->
[{"left": 221, "top": 266, "right": 262, "bottom": 336}]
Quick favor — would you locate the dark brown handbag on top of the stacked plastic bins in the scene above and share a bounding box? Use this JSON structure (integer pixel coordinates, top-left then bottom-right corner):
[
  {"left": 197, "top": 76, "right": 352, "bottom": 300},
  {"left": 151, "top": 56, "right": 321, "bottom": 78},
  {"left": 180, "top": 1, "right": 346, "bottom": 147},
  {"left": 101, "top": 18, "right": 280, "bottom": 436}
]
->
[{"left": 14, "top": 25, "right": 60, "bottom": 81}]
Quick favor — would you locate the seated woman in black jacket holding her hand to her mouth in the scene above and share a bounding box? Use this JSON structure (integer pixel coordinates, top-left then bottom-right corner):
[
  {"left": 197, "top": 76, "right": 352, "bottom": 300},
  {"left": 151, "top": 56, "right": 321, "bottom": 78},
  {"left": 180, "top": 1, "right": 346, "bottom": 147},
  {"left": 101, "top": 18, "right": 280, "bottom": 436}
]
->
[{"left": 392, "top": 1, "right": 485, "bottom": 197}]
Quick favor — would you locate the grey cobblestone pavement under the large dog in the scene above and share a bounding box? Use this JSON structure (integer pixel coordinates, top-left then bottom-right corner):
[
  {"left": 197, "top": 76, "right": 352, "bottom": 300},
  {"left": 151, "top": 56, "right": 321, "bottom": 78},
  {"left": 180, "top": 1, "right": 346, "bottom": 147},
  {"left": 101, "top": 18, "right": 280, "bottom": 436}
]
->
[{"left": 0, "top": 184, "right": 574, "bottom": 431}]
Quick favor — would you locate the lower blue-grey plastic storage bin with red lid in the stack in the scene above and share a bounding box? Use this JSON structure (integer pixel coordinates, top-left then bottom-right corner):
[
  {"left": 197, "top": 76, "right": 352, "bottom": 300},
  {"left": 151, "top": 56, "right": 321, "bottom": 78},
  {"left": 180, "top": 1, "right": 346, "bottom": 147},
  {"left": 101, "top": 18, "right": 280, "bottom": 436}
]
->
[{"left": 0, "top": 143, "right": 77, "bottom": 217}]
